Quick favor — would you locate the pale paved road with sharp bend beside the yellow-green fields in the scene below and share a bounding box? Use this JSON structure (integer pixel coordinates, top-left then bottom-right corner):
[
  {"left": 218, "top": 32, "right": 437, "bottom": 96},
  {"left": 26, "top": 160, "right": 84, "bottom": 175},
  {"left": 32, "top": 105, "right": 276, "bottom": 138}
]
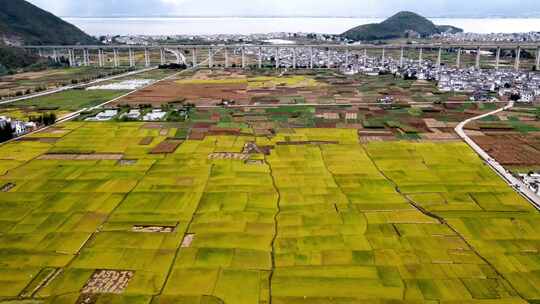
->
[{"left": 456, "top": 101, "right": 540, "bottom": 210}]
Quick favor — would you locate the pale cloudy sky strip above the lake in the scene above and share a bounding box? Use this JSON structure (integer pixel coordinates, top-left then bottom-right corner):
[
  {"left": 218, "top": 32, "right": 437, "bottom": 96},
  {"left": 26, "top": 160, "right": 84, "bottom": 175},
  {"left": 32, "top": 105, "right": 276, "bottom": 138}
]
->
[{"left": 26, "top": 0, "right": 540, "bottom": 17}]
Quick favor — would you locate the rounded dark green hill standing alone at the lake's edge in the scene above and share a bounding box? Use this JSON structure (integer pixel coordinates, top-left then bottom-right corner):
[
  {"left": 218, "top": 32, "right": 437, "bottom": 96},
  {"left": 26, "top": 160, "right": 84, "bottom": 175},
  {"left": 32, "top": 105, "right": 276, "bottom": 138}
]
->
[{"left": 342, "top": 12, "right": 463, "bottom": 41}]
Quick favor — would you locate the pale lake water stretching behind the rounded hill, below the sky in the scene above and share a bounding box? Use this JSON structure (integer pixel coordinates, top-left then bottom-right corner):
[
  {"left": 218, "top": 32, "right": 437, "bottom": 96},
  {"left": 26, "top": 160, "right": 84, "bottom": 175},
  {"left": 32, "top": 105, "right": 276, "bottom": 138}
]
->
[{"left": 64, "top": 17, "right": 540, "bottom": 36}]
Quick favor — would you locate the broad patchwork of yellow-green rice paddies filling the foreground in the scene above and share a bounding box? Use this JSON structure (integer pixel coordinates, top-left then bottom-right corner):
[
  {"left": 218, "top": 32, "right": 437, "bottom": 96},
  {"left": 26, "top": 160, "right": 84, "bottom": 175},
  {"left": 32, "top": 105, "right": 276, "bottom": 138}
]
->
[{"left": 0, "top": 122, "right": 540, "bottom": 304}]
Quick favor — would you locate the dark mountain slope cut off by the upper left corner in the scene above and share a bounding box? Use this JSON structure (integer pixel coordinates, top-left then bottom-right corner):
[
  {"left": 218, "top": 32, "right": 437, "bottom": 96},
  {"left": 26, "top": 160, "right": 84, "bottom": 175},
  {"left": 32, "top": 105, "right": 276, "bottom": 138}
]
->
[{"left": 0, "top": 0, "right": 96, "bottom": 45}]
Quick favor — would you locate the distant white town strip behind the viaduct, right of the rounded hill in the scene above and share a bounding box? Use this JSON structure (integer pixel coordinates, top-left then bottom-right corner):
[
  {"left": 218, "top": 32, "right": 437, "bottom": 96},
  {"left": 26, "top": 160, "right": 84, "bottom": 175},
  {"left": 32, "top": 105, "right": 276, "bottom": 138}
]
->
[{"left": 432, "top": 32, "right": 540, "bottom": 43}]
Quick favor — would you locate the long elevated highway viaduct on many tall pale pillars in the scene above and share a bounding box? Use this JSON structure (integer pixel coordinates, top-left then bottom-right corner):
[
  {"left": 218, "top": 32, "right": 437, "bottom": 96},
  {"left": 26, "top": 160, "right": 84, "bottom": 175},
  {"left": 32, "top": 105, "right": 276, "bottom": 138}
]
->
[{"left": 23, "top": 43, "right": 540, "bottom": 71}]
